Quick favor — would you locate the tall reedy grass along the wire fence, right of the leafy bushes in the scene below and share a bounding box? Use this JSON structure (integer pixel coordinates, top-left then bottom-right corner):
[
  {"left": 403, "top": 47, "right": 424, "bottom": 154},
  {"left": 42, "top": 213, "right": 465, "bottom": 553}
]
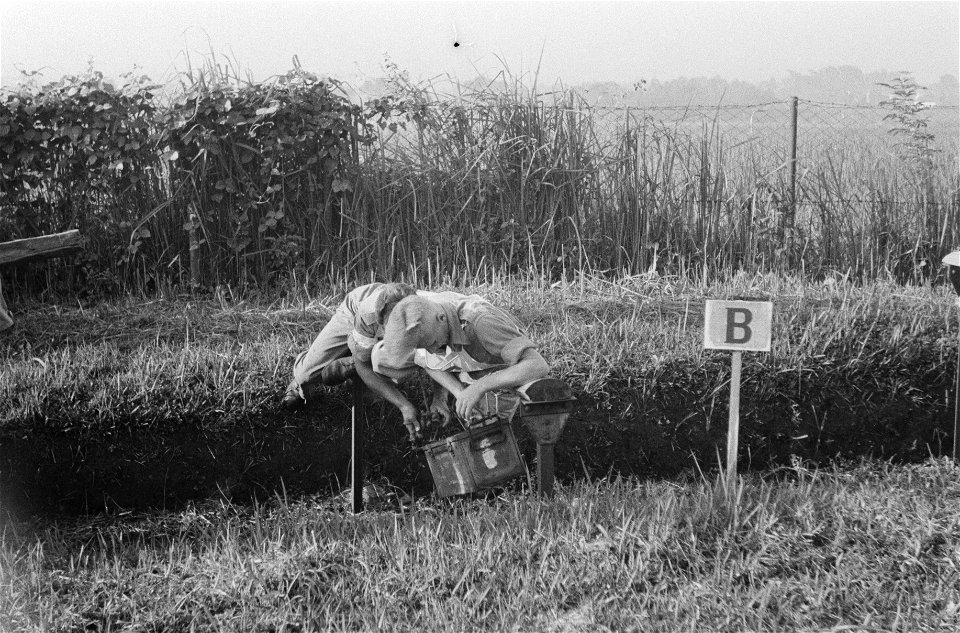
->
[{"left": 344, "top": 73, "right": 960, "bottom": 282}]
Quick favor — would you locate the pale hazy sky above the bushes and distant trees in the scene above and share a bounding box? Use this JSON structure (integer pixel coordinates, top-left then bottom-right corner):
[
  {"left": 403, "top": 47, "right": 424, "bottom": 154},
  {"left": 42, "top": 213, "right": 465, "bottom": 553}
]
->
[{"left": 0, "top": 0, "right": 960, "bottom": 91}]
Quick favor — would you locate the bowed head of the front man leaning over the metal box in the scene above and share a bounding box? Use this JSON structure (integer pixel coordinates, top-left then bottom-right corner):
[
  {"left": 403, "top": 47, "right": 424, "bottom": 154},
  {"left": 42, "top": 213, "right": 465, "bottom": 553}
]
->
[{"left": 383, "top": 295, "right": 450, "bottom": 368}]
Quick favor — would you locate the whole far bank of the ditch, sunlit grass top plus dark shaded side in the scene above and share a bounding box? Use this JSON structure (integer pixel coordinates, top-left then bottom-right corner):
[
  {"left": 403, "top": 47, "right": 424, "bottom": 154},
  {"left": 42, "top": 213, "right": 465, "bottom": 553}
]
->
[{"left": 0, "top": 276, "right": 957, "bottom": 511}]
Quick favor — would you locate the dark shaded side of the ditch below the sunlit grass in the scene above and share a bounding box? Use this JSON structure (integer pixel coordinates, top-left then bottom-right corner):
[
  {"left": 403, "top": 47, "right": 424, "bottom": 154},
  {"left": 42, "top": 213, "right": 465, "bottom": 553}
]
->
[{"left": 0, "top": 360, "right": 953, "bottom": 513}]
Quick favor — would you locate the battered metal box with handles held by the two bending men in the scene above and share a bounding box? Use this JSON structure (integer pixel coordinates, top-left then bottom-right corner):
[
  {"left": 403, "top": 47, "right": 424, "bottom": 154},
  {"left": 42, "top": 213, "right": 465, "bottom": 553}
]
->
[{"left": 423, "top": 419, "right": 524, "bottom": 497}]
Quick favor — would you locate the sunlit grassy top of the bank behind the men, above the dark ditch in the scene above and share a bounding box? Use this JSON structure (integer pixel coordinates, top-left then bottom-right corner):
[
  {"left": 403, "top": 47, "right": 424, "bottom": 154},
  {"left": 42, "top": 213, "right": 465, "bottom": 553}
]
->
[{"left": 0, "top": 275, "right": 956, "bottom": 433}]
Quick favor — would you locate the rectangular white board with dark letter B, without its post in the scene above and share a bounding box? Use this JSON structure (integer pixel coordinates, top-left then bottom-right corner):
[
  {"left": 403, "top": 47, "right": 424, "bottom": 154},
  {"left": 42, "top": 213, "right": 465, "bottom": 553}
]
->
[{"left": 703, "top": 299, "right": 773, "bottom": 352}]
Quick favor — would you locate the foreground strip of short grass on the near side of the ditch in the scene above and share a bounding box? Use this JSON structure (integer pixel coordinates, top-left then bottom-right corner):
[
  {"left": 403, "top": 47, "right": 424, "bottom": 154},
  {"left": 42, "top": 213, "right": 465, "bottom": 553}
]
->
[{"left": 0, "top": 460, "right": 960, "bottom": 632}]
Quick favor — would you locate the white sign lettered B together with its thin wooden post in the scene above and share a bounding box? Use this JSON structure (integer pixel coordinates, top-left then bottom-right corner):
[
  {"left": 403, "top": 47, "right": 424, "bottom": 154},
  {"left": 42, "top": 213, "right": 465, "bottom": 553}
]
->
[{"left": 703, "top": 299, "right": 773, "bottom": 490}]
